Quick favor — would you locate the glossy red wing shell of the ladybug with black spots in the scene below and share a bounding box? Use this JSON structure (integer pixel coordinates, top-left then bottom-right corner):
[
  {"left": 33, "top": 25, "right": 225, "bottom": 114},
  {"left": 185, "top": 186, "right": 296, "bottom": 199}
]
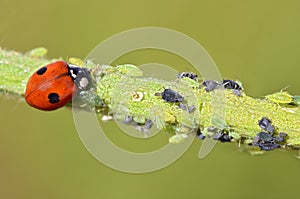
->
[{"left": 25, "top": 61, "right": 76, "bottom": 111}]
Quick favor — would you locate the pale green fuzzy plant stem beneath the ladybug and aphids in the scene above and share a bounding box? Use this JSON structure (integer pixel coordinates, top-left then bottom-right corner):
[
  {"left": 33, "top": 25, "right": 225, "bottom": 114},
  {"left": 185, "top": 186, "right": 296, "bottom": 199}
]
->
[{"left": 0, "top": 49, "right": 300, "bottom": 147}]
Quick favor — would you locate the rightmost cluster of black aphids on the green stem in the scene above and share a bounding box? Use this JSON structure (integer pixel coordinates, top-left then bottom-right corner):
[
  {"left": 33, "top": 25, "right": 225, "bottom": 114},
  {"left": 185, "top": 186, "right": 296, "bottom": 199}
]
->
[{"left": 252, "top": 117, "right": 287, "bottom": 151}]
